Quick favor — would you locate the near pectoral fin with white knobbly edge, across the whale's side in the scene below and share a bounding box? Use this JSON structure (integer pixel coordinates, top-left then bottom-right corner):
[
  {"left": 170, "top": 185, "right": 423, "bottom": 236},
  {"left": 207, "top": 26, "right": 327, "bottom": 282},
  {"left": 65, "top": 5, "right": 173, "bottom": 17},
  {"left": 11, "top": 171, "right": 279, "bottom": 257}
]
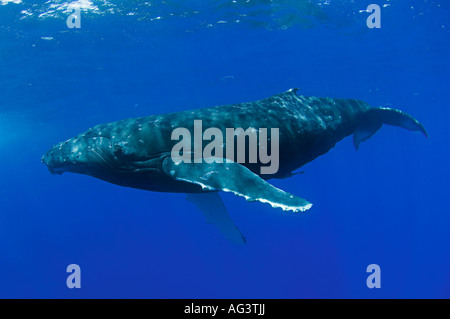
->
[{"left": 163, "top": 157, "right": 312, "bottom": 212}]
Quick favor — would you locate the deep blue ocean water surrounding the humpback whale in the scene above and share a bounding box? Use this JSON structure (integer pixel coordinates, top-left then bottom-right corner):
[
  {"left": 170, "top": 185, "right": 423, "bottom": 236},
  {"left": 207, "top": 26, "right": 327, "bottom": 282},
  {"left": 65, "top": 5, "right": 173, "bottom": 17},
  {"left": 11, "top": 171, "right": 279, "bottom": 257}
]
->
[{"left": 0, "top": 0, "right": 450, "bottom": 298}]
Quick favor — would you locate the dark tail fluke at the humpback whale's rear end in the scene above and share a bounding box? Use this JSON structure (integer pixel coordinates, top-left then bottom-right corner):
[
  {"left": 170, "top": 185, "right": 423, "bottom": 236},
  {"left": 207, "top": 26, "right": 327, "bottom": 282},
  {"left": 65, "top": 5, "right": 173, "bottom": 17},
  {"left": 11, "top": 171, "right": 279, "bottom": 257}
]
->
[{"left": 353, "top": 107, "right": 428, "bottom": 150}]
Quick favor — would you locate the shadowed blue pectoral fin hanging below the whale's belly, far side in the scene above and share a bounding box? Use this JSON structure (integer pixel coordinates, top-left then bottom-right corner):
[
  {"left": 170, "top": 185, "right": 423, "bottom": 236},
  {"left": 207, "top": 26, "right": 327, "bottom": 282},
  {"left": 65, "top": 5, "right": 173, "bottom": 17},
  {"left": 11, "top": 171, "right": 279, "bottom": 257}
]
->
[{"left": 186, "top": 192, "right": 246, "bottom": 244}]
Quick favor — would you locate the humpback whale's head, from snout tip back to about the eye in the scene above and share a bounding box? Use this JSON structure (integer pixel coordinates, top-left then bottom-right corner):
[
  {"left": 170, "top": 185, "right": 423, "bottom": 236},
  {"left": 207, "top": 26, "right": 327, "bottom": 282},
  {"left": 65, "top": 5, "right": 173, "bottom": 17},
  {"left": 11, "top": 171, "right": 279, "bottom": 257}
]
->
[{"left": 41, "top": 135, "right": 118, "bottom": 178}]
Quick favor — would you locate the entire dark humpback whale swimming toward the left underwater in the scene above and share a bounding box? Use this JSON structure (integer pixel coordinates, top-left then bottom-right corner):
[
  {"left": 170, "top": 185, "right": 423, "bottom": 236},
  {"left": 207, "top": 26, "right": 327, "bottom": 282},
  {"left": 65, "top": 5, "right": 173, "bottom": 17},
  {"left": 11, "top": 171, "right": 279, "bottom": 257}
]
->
[{"left": 42, "top": 89, "right": 427, "bottom": 242}]
